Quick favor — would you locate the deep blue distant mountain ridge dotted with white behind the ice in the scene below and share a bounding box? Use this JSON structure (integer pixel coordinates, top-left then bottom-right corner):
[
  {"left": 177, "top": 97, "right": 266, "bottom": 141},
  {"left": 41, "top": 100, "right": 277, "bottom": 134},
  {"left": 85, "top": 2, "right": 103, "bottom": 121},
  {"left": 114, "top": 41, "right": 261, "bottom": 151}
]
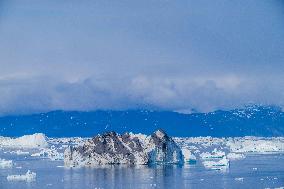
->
[{"left": 0, "top": 106, "right": 284, "bottom": 137}]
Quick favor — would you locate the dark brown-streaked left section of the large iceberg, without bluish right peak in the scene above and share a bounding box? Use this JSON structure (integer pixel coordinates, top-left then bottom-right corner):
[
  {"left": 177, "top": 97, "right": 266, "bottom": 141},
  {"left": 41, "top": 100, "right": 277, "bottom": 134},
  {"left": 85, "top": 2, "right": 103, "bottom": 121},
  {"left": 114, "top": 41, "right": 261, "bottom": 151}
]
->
[{"left": 64, "top": 132, "right": 147, "bottom": 167}]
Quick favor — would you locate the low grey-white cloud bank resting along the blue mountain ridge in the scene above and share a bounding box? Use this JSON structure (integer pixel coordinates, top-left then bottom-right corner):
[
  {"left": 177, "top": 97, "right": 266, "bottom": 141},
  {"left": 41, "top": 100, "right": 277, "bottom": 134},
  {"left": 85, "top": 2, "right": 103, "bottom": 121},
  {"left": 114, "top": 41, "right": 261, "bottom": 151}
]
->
[{"left": 0, "top": 75, "right": 284, "bottom": 114}]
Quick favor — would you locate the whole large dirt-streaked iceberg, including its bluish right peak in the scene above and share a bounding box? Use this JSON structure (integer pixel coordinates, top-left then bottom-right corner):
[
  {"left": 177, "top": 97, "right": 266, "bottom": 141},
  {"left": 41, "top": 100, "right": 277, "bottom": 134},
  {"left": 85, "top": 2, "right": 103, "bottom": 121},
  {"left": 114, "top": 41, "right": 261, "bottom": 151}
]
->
[{"left": 64, "top": 130, "right": 183, "bottom": 167}]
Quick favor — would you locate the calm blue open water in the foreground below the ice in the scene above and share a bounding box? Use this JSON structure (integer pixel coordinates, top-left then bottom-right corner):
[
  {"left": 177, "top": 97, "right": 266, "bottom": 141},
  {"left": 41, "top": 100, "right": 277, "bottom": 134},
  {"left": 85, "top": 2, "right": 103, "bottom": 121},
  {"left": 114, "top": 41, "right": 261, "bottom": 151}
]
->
[{"left": 0, "top": 154, "right": 284, "bottom": 189}]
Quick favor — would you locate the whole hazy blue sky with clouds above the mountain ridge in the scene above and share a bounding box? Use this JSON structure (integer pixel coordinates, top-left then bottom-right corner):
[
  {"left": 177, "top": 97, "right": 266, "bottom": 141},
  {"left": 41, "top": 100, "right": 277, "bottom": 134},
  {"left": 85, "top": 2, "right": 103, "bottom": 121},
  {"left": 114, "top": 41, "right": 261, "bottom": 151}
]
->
[{"left": 0, "top": 0, "right": 284, "bottom": 114}]
